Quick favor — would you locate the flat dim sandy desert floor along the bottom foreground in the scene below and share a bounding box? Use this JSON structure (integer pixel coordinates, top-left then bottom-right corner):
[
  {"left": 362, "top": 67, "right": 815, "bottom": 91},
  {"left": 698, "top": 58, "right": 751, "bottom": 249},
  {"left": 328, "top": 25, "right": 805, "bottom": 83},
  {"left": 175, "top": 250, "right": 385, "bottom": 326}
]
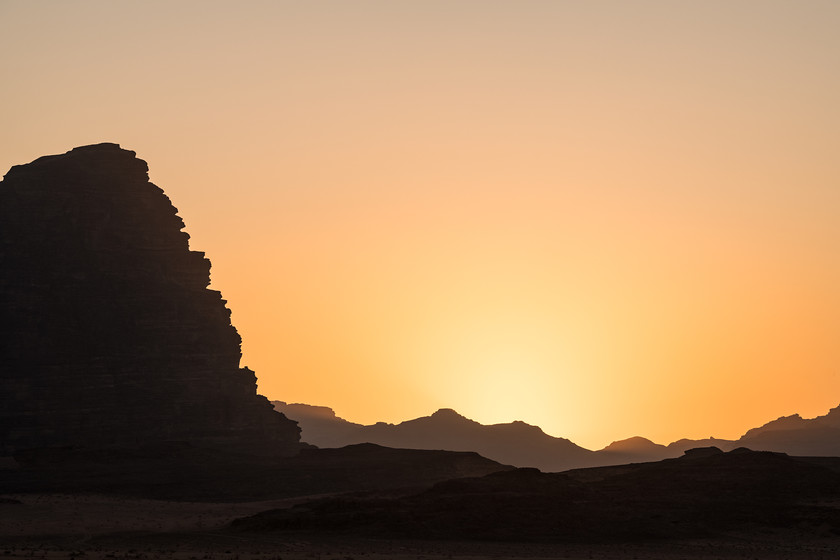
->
[{"left": 0, "top": 494, "right": 840, "bottom": 560}]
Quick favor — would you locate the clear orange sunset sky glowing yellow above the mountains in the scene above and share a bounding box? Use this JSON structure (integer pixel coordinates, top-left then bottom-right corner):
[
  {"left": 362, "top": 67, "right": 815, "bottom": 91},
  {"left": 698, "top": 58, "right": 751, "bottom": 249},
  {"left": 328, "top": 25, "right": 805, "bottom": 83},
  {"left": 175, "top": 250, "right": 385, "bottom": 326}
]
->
[{"left": 0, "top": 0, "right": 840, "bottom": 449}]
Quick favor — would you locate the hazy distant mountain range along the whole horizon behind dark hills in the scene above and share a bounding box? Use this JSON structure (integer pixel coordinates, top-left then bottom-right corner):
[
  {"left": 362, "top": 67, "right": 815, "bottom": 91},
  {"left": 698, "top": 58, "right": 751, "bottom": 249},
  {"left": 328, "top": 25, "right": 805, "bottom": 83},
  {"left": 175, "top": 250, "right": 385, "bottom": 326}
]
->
[{"left": 272, "top": 401, "right": 840, "bottom": 472}]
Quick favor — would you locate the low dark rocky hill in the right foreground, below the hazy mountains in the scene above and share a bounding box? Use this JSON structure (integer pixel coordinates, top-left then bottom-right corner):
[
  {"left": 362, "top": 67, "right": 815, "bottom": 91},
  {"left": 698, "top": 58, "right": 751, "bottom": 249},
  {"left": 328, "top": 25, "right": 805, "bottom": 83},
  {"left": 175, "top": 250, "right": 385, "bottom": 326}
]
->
[{"left": 232, "top": 448, "right": 840, "bottom": 542}]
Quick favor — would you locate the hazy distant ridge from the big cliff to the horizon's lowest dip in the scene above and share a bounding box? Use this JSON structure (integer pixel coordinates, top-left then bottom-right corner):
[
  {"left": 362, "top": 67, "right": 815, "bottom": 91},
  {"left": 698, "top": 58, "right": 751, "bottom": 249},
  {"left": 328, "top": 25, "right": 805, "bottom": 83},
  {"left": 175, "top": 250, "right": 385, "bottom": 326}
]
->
[{"left": 273, "top": 401, "right": 598, "bottom": 471}]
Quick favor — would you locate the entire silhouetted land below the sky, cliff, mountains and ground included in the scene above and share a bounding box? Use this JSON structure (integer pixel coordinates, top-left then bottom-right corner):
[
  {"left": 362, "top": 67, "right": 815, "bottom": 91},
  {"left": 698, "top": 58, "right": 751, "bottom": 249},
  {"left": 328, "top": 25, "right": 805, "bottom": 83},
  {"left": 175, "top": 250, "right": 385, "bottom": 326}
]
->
[{"left": 0, "top": 143, "right": 840, "bottom": 559}]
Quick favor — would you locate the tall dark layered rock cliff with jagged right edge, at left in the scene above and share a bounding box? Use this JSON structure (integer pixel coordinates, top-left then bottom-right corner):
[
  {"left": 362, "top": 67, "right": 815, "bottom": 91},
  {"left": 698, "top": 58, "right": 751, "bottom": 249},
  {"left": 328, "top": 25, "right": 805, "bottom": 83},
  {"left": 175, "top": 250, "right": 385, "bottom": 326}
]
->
[{"left": 0, "top": 144, "right": 300, "bottom": 455}]
